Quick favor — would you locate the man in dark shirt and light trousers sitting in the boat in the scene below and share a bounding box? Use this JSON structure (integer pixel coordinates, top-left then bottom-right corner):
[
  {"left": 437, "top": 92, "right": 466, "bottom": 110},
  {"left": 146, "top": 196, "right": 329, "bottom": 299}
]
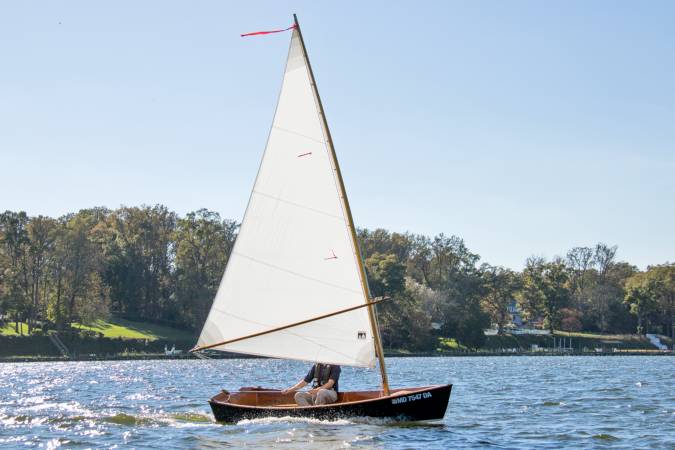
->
[{"left": 281, "top": 363, "right": 341, "bottom": 406}]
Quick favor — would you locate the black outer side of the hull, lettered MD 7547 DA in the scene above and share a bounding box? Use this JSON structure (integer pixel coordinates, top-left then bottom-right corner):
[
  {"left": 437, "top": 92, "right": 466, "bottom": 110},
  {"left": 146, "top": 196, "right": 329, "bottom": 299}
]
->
[{"left": 209, "top": 384, "right": 452, "bottom": 423}]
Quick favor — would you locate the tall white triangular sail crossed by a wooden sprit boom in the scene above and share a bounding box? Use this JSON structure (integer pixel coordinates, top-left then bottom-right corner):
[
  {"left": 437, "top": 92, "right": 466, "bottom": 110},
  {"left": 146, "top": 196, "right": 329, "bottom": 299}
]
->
[{"left": 198, "top": 30, "right": 375, "bottom": 367}]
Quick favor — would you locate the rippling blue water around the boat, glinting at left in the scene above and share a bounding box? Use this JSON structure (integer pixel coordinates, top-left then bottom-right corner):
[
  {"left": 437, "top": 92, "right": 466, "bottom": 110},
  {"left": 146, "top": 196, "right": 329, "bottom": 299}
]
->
[{"left": 0, "top": 356, "right": 675, "bottom": 449}]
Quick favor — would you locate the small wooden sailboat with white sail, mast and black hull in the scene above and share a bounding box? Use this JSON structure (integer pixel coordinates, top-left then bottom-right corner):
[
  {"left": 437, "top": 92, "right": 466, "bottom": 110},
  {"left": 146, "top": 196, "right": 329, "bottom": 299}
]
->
[{"left": 191, "top": 15, "right": 452, "bottom": 422}]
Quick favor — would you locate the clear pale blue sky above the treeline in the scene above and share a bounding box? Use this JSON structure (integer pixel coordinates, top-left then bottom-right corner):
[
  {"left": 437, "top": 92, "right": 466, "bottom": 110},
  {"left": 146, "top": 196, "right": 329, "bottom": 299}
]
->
[{"left": 0, "top": 0, "right": 675, "bottom": 270}]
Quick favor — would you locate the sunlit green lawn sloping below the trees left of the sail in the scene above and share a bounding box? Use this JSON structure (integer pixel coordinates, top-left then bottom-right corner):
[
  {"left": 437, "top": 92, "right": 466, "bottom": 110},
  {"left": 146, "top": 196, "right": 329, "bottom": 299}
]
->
[{"left": 73, "top": 318, "right": 194, "bottom": 341}]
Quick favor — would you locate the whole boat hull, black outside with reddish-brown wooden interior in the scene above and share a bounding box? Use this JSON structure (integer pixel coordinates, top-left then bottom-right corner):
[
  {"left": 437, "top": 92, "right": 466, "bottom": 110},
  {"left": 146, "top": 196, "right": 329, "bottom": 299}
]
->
[{"left": 209, "top": 384, "right": 452, "bottom": 423}]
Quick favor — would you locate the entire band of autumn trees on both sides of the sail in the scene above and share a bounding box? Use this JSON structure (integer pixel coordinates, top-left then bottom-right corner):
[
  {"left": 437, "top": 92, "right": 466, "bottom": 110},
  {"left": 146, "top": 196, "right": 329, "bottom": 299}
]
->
[{"left": 0, "top": 205, "right": 675, "bottom": 350}]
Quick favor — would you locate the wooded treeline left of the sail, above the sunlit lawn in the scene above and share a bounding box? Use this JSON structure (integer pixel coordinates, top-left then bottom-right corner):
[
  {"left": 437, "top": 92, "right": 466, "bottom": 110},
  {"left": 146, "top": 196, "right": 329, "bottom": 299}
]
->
[{"left": 0, "top": 205, "right": 237, "bottom": 330}]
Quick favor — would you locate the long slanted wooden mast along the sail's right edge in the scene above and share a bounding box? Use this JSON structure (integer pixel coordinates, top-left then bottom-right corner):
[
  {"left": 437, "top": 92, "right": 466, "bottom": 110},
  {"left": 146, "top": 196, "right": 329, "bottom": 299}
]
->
[{"left": 293, "top": 14, "right": 389, "bottom": 395}]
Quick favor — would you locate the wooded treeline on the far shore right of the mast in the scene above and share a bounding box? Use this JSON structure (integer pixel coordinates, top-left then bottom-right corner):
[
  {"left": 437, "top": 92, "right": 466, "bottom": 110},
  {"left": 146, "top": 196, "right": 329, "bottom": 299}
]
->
[{"left": 359, "top": 229, "right": 675, "bottom": 349}]
